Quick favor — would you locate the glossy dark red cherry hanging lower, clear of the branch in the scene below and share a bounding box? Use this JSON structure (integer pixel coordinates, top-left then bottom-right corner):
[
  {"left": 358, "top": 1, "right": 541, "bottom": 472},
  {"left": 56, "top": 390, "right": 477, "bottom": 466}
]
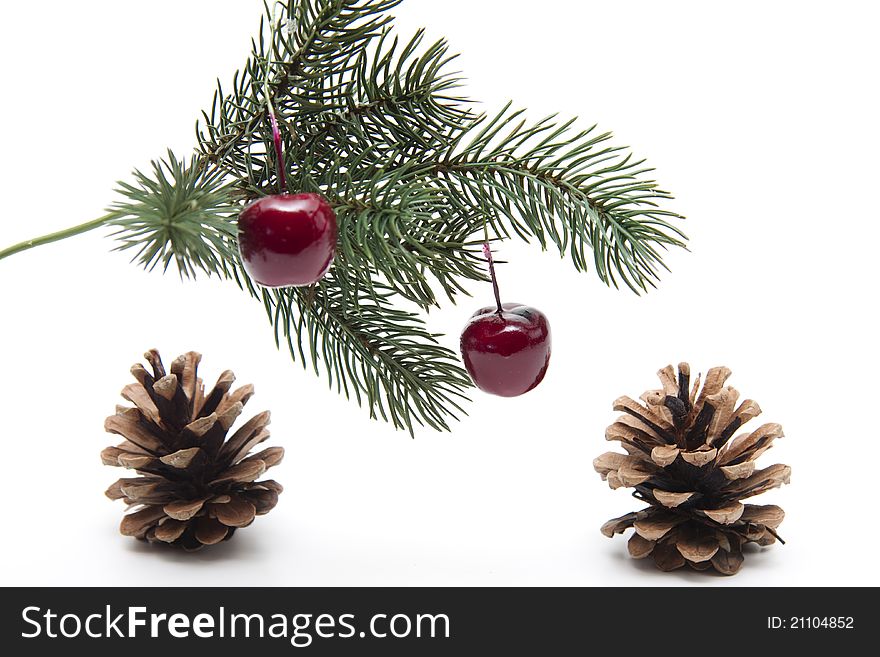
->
[{"left": 461, "top": 303, "right": 550, "bottom": 397}]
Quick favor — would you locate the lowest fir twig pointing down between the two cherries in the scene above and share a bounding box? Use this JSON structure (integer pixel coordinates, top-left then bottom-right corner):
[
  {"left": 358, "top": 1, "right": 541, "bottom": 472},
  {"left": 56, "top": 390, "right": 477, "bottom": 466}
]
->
[{"left": 261, "top": 272, "right": 471, "bottom": 434}]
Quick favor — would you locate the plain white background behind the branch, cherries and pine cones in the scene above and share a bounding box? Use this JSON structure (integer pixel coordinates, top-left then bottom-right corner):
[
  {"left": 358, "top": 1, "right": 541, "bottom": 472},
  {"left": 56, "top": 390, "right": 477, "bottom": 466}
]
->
[{"left": 0, "top": 0, "right": 880, "bottom": 586}]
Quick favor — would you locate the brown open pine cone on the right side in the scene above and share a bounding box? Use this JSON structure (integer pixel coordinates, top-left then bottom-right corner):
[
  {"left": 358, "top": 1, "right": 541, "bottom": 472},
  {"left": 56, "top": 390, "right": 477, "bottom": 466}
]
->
[{"left": 593, "top": 363, "right": 791, "bottom": 575}]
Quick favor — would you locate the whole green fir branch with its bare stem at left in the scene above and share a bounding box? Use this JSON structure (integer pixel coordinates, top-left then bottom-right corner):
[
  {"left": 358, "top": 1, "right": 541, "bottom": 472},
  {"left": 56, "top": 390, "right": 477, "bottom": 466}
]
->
[{"left": 0, "top": 0, "right": 686, "bottom": 433}]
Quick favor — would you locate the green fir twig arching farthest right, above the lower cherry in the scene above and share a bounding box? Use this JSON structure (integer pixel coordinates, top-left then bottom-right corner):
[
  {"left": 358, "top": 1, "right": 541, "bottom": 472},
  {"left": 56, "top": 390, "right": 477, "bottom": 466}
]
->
[{"left": 432, "top": 105, "right": 686, "bottom": 294}]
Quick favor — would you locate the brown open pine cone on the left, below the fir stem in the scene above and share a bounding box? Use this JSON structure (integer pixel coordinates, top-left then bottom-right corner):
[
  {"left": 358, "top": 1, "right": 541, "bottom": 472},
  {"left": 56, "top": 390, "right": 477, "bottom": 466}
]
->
[{"left": 101, "top": 350, "right": 284, "bottom": 550}]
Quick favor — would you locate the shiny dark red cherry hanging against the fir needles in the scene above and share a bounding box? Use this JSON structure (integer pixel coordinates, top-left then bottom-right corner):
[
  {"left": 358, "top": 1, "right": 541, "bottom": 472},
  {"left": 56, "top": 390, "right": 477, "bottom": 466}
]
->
[{"left": 238, "top": 194, "right": 337, "bottom": 287}]
